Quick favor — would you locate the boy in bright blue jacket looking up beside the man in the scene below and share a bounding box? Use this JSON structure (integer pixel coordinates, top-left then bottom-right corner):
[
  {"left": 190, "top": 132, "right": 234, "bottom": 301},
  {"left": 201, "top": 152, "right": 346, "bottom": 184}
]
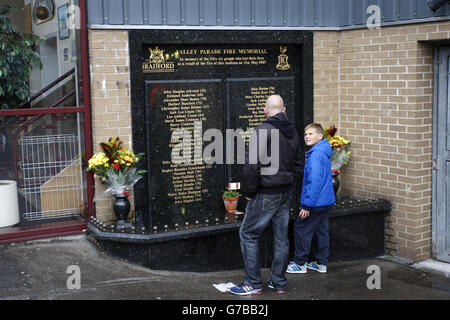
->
[{"left": 286, "top": 123, "right": 335, "bottom": 273}]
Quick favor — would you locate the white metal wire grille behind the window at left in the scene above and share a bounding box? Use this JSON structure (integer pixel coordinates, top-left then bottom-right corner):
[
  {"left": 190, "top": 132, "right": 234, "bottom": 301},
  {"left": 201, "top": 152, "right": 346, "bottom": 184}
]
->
[{"left": 19, "top": 134, "right": 83, "bottom": 220}]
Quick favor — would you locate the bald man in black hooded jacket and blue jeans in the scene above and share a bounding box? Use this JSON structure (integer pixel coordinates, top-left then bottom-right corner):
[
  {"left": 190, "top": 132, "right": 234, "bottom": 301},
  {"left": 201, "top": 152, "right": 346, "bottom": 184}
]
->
[{"left": 230, "top": 95, "right": 304, "bottom": 295}]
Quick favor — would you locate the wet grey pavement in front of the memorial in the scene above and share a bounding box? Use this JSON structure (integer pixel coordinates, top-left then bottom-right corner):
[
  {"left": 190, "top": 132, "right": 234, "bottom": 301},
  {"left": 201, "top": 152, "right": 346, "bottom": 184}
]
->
[{"left": 0, "top": 236, "right": 450, "bottom": 302}]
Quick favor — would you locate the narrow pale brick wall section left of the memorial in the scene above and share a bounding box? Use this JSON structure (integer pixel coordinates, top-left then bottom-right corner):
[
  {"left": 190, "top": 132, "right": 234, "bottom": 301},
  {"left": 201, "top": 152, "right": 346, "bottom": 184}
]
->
[{"left": 89, "top": 30, "right": 133, "bottom": 221}]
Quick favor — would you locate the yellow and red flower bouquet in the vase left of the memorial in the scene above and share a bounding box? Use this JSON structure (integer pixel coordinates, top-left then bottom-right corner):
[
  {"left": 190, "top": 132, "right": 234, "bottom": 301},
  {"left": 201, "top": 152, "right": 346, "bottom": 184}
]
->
[{"left": 87, "top": 137, "right": 147, "bottom": 196}]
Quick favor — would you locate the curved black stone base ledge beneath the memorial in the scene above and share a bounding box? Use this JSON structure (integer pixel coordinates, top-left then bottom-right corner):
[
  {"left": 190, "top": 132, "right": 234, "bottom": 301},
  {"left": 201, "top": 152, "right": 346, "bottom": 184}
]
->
[{"left": 88, "top": 198, "right": 391, "bottom": 272}]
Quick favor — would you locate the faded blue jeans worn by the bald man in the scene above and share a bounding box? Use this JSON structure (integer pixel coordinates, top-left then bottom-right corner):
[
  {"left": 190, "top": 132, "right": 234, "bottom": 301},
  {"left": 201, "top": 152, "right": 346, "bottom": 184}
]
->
[{"left": 239, "top": 192, "right": 290, "bottom": 289}]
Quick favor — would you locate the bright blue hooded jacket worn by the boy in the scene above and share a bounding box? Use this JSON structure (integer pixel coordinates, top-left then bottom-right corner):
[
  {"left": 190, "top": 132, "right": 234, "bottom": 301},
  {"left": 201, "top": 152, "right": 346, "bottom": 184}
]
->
[{"left": 301, "top": 139, "right": 336, "bottom": 211}]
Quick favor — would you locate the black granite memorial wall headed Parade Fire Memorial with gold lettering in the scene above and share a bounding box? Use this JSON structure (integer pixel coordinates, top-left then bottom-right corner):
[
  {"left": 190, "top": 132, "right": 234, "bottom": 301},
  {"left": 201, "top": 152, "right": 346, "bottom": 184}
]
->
[{"left": 130, "top": 31, "right": 312, "bottom": 233}]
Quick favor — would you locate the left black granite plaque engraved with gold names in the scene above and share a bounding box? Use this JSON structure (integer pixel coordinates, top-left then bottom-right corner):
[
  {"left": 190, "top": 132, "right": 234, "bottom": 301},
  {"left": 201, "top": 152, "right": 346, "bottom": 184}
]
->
[{"left": 146, "top": 79, "right": 224, "bottom": 230}]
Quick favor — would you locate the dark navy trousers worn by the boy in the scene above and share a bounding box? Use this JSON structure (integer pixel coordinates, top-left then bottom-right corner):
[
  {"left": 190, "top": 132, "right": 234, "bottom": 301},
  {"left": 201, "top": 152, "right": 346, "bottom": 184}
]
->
[{"left": 294, "top": 207, "right": 332, "bottom": 265}]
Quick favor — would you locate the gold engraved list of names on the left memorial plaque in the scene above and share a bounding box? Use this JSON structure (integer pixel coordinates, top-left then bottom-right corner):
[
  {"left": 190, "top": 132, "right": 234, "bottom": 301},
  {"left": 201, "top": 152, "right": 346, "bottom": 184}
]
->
[{"left": 150, "top": 82, "right": 221, "bottom": 205}]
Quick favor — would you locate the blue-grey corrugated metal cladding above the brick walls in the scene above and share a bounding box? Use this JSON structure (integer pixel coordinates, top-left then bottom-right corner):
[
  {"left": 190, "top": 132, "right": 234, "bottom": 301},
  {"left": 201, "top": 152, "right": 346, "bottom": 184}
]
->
[{"left": 87, "top": 0, "right": 450, "bottom": 28}]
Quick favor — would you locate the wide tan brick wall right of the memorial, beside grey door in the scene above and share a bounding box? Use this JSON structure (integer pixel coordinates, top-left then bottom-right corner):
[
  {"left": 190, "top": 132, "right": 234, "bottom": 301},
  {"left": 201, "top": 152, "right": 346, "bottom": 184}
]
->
[{"left": 314, "top": 22, "right": 450, "bottom": 261}]
